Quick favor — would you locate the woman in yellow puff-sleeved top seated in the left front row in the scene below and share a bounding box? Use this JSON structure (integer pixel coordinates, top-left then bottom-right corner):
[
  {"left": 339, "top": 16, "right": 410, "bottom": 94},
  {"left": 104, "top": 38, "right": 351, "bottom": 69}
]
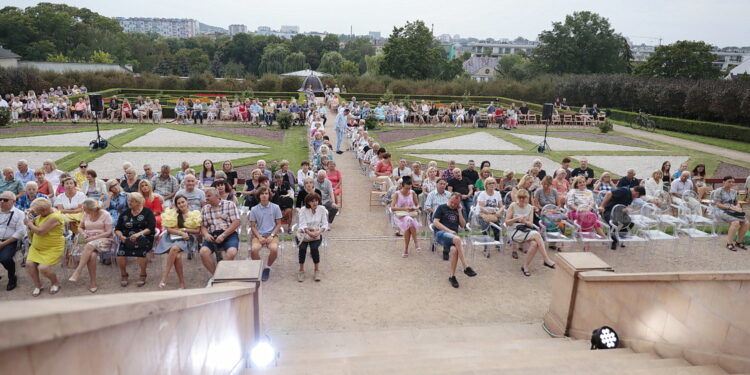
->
[{"left": 154, "top": 195, "right": 203, "bottom": 289}]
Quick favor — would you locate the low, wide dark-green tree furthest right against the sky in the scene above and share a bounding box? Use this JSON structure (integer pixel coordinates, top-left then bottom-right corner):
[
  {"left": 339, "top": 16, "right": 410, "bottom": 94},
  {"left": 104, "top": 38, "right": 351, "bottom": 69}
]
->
[{"left": 635, "top": 40, "right": 721, "bottom": 79}]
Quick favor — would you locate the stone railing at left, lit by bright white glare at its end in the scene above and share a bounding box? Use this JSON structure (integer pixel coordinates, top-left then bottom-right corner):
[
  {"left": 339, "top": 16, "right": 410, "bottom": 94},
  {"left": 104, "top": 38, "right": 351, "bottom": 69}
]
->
[{"left": 0, "top": 282, "right": 258, "bottom": 375}]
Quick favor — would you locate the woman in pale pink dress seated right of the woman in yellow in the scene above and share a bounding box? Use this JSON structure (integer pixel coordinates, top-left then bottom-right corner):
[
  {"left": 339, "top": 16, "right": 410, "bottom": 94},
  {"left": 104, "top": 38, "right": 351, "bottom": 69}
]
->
[{"left": 68, "top": 198, "right": 113, "bottom": 293}]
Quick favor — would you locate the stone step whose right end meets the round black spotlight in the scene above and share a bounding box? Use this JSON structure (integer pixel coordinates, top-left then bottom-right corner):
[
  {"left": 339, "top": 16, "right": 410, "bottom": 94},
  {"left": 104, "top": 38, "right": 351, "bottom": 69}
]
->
[{"left": 279, "top": 337, "right": 590, "bottom": 365}]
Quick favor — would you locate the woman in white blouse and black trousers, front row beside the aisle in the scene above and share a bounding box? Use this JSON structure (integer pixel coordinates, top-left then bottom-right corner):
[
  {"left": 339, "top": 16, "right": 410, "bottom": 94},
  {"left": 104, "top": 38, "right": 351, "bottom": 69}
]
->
[{"left": 297, "top": 193, "right": 328, "bottom": 282}]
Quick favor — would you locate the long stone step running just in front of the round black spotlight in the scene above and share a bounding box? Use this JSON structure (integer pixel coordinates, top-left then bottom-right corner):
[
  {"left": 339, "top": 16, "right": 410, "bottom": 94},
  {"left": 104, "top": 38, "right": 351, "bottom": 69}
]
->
[{"left": 250, "top": 349, "right": 655, "bottom": 375}]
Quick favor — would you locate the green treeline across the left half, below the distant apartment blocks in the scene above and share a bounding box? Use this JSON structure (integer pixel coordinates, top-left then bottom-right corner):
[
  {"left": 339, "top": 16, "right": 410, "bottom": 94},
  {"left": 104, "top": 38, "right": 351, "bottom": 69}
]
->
[{"left": 0, "top": 3, "right": 375, "bottom": 78}]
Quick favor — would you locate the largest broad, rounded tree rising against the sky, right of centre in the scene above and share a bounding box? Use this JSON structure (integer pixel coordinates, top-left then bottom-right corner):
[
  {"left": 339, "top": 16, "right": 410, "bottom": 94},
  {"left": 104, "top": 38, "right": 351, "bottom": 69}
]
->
[{"left": 532, "top": 11, "right": 630, "bottom": 74}]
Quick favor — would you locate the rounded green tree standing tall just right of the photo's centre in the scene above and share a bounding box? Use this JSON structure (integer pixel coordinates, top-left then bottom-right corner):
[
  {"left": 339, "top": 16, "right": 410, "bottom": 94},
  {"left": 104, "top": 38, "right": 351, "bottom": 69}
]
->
[{"left": 380, "top": 21, "right": 445, "bottom": 79}]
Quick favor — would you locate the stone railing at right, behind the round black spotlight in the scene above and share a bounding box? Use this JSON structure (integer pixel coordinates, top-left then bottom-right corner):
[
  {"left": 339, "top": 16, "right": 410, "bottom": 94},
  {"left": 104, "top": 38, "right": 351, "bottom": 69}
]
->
[{"left": 544, "top": 253, "right": 750, "bottom": 373}]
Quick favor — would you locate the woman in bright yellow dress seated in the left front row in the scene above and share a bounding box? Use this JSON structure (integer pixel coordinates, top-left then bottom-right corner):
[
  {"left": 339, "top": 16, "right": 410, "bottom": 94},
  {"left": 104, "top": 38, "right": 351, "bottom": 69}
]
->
[{"left": 24, "top": 198, "right": 65, "bottom": 297}]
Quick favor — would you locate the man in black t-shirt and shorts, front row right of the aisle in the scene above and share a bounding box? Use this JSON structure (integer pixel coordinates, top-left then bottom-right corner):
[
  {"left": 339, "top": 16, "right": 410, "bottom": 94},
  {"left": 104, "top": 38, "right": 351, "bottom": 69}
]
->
[{"left": 432, "top": 193, "right": 477, "bottom": 288}]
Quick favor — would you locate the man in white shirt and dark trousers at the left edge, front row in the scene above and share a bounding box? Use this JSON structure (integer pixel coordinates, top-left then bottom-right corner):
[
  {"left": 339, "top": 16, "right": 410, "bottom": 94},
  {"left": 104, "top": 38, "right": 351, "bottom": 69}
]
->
[{"left": 0, "top": 191, "right": 26, "bottom": 290}]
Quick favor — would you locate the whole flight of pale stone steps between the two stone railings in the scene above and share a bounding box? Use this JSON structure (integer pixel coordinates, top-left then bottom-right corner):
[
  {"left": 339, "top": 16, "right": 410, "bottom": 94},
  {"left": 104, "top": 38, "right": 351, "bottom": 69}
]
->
[{"left": 244, "top": 324, "right": 726, "bottom": 375}]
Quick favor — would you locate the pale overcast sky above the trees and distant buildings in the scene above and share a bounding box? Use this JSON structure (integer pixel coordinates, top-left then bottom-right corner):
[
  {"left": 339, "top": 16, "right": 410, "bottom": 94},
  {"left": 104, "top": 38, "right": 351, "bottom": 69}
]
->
[{"left": 1, "top": 0, "right": 750, "bottom": 47}]
